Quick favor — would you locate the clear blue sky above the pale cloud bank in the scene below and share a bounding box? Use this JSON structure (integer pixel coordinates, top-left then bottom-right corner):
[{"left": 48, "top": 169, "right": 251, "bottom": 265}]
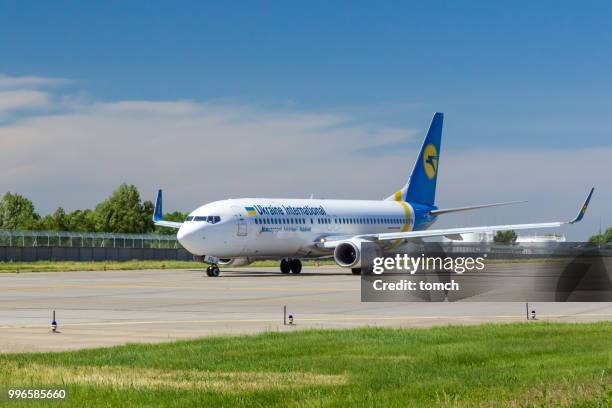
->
[{"left": 0, "top": 1, "right": 612, "bottom": 239}]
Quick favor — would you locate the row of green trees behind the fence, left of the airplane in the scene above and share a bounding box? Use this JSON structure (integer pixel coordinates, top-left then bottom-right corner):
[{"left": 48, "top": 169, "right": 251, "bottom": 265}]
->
[{"left": 0, "top": 183, "right": 187, "bottom": 234}]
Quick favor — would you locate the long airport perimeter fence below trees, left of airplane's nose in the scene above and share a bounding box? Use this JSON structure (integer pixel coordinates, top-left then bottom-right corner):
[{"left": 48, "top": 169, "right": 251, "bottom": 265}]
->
[{"left": 0, "top": 230, "right": 193, "bottom": 262}]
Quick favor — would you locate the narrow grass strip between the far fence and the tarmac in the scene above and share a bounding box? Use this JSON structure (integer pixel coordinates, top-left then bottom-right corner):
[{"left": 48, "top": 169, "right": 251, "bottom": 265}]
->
[{"left": 0, "top": 260, "right": 335, "bottom": 273}]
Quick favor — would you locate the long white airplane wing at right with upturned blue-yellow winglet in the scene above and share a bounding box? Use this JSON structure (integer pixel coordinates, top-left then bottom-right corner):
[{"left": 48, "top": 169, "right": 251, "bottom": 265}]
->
[{"left": 319, "top": 187, "right": 595, "bottom": 248}]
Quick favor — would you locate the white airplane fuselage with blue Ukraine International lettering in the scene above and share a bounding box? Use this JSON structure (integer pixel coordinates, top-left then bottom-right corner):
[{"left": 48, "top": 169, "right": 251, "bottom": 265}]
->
[{"left": 177, "top": 198, "right": 415, "bottom": 258}]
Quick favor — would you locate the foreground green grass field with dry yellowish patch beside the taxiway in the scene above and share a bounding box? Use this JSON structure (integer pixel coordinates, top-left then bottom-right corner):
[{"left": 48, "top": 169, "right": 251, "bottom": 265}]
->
[{"left": 0, "top": 322, "right": 612, "bottom": 407}]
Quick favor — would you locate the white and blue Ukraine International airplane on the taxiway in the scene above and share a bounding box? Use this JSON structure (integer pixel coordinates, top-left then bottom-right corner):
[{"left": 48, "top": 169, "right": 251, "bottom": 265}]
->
[{"left": 153, "top": 112, "right": 595, "bottom": 277}]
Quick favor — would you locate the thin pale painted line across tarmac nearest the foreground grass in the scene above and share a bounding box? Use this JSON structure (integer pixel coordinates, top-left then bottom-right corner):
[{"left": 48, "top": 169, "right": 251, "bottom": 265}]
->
[{"left": 0, "top": 313, "right": 612, "bottom": 329}]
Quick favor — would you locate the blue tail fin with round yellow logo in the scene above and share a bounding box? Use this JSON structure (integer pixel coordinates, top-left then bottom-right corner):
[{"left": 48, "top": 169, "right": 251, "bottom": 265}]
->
[{"left": 404, "top": 112, "right": 444, "bottom": 206}]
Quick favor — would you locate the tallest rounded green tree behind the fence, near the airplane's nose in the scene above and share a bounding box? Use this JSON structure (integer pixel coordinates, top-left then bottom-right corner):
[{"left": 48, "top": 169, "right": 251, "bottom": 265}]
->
[{"left": 95, "top": 183, "right": 153, "bottom": 234}]
